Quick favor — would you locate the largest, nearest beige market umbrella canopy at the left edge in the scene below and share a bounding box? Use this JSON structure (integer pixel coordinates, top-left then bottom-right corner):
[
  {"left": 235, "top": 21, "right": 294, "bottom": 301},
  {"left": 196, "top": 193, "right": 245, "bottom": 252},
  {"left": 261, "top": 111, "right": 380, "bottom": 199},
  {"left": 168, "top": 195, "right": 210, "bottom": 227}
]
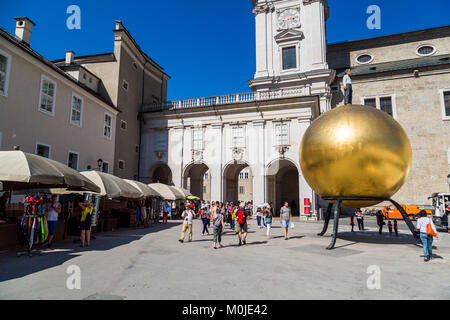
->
[{"left": 0, "top": 150, "right": 100, "bottom": 192}]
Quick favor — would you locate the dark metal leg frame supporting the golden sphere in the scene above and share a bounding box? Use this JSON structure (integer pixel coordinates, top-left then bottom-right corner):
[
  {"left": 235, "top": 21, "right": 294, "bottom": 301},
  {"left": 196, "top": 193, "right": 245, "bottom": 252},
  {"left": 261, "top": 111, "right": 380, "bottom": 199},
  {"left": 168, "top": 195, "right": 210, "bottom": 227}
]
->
[{"left": 317, "top": 197, "right": 419, "bottom": 250}]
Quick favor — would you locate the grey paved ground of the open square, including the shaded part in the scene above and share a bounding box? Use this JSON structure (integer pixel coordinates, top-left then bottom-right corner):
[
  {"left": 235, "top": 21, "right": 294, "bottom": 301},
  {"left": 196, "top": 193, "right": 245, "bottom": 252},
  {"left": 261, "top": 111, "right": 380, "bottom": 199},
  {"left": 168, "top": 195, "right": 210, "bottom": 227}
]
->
[{"left": 0, "top": 218, "right": 450, "bottom": 300}]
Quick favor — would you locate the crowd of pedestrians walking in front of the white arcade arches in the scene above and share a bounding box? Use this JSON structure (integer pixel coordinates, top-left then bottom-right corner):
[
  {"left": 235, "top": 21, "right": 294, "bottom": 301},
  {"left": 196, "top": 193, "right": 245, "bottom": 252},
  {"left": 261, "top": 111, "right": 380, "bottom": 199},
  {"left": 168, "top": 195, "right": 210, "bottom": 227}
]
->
[{"left": 178, "top": 201, "right": 293, "bottom": 249}]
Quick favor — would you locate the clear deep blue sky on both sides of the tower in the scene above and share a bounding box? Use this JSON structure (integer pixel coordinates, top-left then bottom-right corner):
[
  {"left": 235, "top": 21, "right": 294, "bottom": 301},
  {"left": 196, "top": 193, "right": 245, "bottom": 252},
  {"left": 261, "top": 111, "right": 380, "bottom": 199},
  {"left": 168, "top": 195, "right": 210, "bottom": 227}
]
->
[{"left": 0, "top": 0, "right": 450, "bottom": 100}]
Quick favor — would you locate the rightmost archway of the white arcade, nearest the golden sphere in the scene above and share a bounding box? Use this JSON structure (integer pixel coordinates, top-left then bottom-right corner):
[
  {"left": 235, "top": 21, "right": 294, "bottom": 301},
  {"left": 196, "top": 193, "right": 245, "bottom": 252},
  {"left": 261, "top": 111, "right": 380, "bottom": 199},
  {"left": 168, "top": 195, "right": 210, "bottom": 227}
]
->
[{"left": 266, "top": 159, "right": 300, "bottom": 216}]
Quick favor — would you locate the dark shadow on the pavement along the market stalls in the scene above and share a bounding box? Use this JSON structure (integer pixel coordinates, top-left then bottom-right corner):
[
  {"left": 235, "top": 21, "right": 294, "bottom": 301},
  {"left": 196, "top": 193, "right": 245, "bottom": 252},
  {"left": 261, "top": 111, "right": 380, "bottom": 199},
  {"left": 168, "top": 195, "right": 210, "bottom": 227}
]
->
[{"left": 0, "top": 221, "right": 181, "bottom": 283}]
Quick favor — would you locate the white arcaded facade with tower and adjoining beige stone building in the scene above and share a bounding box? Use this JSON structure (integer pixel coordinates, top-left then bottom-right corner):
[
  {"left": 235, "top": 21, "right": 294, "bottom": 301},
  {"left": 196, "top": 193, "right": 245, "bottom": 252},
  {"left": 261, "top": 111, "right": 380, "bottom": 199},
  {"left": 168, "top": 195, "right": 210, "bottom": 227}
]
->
[{"left": 140, "top": 0, "right": 450, "bottom": 217}]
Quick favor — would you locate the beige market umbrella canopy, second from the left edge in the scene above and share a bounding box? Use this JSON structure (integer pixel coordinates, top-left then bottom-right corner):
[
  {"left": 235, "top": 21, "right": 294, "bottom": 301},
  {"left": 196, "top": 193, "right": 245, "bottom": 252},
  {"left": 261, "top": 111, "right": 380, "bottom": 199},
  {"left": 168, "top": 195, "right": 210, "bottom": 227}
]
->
[{"left": 81, "top": 170, "right": 142, "bottom": 199}]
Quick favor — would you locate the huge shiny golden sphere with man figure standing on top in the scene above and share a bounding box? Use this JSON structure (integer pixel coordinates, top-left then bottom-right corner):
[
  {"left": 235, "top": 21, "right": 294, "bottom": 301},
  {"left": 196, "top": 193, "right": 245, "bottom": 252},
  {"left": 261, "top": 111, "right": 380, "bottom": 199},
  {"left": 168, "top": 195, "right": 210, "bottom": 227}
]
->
[{"left": 300, "top": 105, "right": 412, "bottom": 208}]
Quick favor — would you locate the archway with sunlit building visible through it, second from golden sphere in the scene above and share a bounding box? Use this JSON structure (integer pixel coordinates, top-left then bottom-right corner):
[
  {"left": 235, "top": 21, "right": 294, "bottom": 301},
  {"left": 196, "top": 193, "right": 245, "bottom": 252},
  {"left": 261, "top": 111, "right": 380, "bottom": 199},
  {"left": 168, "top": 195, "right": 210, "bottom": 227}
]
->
[{"left": 223, "top": 162, "right": 253, "bottom": 202}]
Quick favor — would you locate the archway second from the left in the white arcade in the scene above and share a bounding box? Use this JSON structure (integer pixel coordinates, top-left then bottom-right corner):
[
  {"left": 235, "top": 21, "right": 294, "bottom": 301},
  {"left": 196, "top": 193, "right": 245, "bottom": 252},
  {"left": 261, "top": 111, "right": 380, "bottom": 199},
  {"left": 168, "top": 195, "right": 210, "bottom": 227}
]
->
[{"left": 183, "top": 163, "right": 211, "bottom": 201}]
